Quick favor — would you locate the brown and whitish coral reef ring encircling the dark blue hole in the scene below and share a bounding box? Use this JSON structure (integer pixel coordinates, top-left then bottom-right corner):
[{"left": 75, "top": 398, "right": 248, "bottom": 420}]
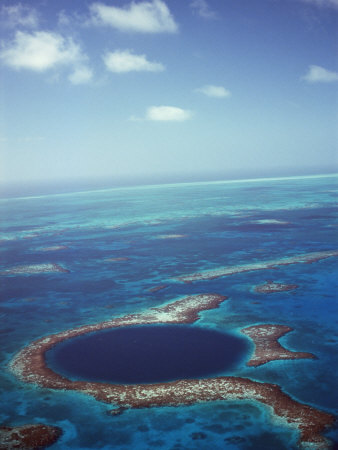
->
[{"left": 10, "top": 294, "right": 335, "bottom": 449}]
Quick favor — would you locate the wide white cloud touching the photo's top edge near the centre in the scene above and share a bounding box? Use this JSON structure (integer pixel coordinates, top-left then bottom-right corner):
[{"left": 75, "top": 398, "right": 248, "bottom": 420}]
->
[{"left": 90, "top": 0, "right": 178, "bottom": 33}]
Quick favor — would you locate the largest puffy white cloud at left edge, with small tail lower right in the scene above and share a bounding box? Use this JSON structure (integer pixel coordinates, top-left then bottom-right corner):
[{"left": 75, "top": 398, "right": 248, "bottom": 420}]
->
[{"left": 0, "top": 31, "right": 92, "bottom": 84}]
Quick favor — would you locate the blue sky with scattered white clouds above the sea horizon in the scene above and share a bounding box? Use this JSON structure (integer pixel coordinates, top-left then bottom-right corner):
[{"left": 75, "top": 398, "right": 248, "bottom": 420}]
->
[{"left": 0, "top": 0, "right": 338, "bottom": 183}]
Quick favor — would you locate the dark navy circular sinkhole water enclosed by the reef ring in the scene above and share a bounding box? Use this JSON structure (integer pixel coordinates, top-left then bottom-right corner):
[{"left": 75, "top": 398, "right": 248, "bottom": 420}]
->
[{"left": 48, "top": 325, "right": 248, "bottom": 384}]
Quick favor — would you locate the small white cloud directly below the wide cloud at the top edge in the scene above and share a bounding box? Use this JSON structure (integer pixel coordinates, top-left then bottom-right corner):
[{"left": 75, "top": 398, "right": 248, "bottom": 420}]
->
[{"left": 103, "top": 50, "right": 165, "bottom": 73}]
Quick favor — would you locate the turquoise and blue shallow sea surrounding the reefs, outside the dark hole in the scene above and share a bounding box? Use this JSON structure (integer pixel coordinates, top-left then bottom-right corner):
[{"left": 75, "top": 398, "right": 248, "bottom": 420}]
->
[{"left": 0, "top": 176, "right": 338, "bottom": 450}]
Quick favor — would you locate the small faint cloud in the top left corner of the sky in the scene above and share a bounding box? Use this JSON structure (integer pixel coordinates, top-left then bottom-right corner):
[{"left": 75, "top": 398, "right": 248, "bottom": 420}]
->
[{"left": 0, "top": 3, "right": 39, "bottom": 28}]
